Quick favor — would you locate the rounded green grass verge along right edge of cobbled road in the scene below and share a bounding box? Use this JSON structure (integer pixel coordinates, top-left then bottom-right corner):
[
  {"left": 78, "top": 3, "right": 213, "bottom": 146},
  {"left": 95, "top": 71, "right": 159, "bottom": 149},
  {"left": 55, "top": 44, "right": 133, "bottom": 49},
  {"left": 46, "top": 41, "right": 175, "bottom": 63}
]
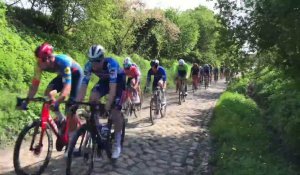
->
[{"left": 210, "top": 92, "right": 298, "bottom": 175}]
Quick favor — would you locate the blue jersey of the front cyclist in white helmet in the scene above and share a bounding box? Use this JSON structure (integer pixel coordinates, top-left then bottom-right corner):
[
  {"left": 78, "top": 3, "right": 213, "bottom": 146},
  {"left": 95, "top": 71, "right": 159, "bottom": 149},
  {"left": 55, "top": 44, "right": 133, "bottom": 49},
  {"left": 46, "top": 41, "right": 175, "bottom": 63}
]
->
[{"left": 82, "top": 58, "right": 124, "bottom": 84}]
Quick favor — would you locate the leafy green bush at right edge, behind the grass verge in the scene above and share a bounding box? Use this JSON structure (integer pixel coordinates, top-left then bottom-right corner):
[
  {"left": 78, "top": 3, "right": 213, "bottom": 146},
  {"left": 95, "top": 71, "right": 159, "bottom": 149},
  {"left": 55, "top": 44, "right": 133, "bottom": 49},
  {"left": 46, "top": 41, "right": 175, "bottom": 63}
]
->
[{"left": 253, "top": 69, "right": 300, "bottom": 156}]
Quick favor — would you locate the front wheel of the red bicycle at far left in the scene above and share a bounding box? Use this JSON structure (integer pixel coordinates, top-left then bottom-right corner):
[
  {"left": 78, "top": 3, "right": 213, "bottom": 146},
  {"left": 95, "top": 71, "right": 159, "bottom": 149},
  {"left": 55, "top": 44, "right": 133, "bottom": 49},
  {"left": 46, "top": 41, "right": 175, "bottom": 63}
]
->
[{"left": 13, "top": 120, "right": 53, "bottom": 175}]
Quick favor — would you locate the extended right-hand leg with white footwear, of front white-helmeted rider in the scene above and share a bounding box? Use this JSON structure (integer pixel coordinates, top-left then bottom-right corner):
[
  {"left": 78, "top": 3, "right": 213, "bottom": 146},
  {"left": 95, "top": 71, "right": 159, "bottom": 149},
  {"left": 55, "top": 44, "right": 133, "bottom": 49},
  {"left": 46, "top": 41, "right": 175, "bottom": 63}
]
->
[{"left": 111, "top": 74, "right": 126, "bottom": 159}]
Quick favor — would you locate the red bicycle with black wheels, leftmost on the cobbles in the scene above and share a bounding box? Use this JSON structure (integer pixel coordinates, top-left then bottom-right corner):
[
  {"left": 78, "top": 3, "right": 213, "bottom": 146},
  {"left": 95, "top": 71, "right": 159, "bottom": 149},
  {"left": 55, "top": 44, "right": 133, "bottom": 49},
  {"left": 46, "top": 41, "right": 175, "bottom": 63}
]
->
[{"left": 13, "top": 97, "right": 80, "bottom": 175}]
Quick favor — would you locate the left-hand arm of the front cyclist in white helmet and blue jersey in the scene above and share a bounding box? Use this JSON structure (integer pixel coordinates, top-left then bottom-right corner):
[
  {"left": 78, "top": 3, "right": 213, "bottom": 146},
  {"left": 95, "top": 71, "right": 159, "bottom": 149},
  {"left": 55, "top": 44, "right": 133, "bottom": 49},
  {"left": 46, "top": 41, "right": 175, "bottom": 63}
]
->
[{"left": 76, "top": 62, "right": 92, "bottom": 101}]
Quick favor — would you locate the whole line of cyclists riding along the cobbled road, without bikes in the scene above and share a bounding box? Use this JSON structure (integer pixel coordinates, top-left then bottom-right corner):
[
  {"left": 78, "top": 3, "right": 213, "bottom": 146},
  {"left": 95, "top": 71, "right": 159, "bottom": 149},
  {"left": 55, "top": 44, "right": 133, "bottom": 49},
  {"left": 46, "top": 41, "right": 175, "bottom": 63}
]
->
[{"left": 22, "top": 43, "right": 224, "bottom": 159}]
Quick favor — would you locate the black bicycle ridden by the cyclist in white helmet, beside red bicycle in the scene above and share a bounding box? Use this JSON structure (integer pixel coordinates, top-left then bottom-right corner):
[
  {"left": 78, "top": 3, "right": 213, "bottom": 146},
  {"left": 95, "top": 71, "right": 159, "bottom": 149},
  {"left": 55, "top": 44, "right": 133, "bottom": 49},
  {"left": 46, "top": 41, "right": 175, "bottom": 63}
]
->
[{"left": 66, "top": 102, "right": 125, "bottom": 175}]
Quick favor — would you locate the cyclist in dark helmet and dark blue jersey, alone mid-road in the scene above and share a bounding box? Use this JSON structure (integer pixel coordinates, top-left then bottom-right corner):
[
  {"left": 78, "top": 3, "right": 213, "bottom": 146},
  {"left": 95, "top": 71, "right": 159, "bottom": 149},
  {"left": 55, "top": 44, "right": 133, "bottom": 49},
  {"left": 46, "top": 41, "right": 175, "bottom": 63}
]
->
[{"left": 146, "top": 60, "right": 167, "bottom": 104}]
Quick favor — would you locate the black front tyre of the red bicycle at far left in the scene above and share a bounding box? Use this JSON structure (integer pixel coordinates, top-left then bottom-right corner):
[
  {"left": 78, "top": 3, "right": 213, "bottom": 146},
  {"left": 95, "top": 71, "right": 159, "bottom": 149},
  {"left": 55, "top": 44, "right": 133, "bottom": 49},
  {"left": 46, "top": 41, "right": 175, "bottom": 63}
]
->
[{"left": 13, "top": 120, "right": 53, "bottom": 175}]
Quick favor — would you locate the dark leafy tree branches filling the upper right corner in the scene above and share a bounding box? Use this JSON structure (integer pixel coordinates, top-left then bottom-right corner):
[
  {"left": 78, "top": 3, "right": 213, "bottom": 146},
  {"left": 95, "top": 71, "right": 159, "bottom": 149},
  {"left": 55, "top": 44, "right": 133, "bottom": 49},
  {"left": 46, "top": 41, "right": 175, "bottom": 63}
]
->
[{"left": 218, "top": 0, "right": 300, "bottom": 78}]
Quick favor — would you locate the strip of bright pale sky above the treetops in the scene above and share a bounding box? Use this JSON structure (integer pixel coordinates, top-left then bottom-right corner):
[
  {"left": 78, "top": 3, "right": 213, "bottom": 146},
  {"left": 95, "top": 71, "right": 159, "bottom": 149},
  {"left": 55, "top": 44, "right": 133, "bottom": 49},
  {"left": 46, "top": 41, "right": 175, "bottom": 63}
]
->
[{"left": 141, "top": 0, "right": 216, "bottom": 11}]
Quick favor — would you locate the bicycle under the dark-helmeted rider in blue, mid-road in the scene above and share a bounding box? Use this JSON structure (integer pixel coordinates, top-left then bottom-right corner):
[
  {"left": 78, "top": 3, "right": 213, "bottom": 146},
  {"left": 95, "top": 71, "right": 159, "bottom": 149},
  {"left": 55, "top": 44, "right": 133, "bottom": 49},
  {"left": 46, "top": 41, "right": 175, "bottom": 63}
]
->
[{"left": 145, "top": 86, "right": 167, "bottom": 125}]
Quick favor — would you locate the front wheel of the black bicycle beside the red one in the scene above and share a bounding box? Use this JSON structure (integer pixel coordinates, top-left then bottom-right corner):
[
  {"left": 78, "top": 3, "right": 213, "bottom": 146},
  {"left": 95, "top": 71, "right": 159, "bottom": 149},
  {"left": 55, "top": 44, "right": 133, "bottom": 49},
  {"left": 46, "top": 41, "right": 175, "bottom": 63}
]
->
[{"left": 66, "top": 124, "right": 97, "bottom": 175}]
